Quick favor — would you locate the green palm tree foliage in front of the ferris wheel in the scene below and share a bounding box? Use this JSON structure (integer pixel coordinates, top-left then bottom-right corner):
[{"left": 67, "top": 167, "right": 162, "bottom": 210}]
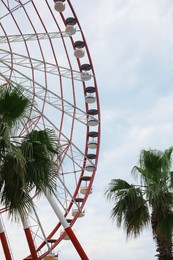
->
[{"left": 0, "top": 84, "right": 58, "bottom": 217}]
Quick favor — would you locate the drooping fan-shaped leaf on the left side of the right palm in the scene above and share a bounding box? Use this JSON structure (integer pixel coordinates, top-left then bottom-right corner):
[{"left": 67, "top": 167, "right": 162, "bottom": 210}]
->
[{"left": 106, "top": 179, "right": 150, "bottom": 237}]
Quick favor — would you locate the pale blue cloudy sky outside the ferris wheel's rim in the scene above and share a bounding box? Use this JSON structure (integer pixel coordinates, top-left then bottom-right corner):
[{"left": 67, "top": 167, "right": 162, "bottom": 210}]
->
[{"left": 1, "top": 0, "right": 173, "bottom": 260}]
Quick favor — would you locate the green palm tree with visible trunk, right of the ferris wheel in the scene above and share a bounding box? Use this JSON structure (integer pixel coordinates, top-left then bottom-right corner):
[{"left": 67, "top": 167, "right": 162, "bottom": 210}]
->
[{"left": 106, "top": 147, "right": 173, "bottom": 260}]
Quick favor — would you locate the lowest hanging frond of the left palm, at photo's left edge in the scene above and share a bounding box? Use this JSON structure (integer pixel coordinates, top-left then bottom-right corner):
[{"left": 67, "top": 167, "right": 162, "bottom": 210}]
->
[{"left": 0, "top": 153, "right": 32, "bottom": 218}]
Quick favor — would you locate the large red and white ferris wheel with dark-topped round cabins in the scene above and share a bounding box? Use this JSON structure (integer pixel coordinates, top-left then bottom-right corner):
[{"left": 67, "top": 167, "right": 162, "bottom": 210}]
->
[{"left": 0, "top": 0, "right": 100, "bottom": 260}]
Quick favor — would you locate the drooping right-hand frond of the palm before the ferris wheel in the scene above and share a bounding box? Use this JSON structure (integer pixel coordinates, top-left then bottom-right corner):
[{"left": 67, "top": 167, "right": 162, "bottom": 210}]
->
[{"left": 21, "top": 132, "right": 56, "bottom": 192}]
